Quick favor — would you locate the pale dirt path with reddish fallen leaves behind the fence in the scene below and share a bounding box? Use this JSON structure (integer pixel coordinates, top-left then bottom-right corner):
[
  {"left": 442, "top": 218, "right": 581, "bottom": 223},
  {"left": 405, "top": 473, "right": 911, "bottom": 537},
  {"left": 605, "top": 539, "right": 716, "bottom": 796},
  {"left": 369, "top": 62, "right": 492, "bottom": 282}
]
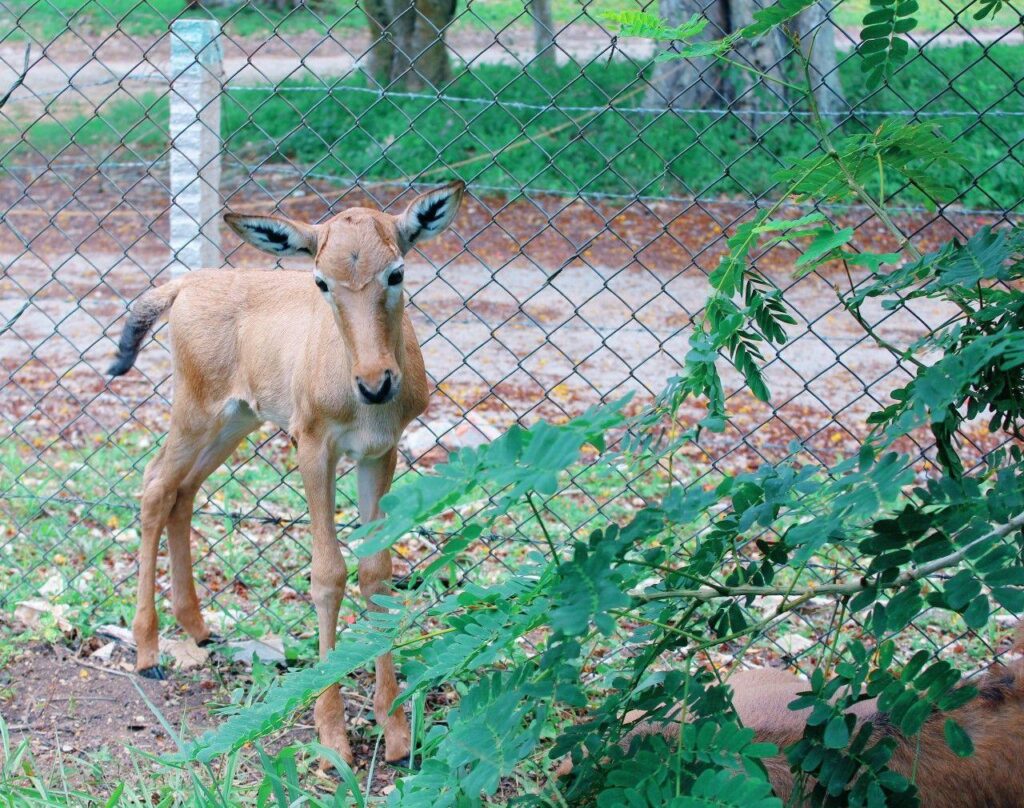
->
[{"left": 0, "top": 163, "right": 997, "bottom": 475}]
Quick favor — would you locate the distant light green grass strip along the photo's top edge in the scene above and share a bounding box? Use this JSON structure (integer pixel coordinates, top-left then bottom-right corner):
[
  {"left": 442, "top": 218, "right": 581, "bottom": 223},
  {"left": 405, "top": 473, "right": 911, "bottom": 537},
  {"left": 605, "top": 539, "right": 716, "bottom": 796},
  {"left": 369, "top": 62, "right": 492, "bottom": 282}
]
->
[{"left": 0, "top": 0, "right": 1020, "bottom": 42}]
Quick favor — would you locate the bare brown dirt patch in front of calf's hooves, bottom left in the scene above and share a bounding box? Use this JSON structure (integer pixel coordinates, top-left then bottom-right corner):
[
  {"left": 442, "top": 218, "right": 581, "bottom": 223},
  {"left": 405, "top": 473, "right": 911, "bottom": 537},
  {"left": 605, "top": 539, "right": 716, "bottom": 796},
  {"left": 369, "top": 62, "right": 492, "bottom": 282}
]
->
[{"left": 0, "top": 627, "right": 407, "bottom": 794}]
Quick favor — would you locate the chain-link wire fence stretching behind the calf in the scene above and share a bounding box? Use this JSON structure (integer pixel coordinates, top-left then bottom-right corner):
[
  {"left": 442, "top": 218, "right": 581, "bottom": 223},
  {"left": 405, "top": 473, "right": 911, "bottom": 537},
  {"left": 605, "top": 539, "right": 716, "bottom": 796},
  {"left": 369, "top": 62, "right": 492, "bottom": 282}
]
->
[{"left": 0, "top": 0, "right": 1024, "bottom": 653}]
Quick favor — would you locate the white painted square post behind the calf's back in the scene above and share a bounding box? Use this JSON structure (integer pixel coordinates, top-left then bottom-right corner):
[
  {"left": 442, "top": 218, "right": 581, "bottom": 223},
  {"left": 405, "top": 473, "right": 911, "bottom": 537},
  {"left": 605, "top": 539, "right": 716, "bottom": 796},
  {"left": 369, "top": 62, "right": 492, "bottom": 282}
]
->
[{"left": 170, "top": 19, "right": 223, "bottom": 274}]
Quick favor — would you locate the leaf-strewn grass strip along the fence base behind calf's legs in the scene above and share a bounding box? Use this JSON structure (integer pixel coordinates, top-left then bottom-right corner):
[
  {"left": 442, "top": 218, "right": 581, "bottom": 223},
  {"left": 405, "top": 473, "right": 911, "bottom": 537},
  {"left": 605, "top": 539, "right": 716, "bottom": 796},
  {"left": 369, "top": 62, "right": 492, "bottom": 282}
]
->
[{"left": 0, "top": 431, "right": 679, "bottom": 661}]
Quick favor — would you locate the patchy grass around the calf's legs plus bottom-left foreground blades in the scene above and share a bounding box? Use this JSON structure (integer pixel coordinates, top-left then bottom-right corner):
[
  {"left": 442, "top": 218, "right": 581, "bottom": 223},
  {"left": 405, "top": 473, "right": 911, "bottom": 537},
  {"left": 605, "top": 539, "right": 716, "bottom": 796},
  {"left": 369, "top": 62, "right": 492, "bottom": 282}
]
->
[{"left": 0, "top": 421, "right": 697, "bottom": 806}]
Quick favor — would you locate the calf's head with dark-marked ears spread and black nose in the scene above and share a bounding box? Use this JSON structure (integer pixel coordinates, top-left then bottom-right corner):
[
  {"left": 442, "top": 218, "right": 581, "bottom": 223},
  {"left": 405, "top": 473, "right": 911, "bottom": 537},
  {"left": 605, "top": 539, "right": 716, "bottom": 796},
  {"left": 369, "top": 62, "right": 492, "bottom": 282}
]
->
[{"left": 224, "top": 181, "right": 466, "bottom": 405}]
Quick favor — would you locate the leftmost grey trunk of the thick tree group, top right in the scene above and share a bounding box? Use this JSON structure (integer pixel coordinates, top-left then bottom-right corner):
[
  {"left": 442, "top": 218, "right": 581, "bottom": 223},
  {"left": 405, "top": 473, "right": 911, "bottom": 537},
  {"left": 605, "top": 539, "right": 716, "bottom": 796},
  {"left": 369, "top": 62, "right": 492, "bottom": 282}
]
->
[{"left": 645, "top": 0, "right": 729, "bottom": 110}]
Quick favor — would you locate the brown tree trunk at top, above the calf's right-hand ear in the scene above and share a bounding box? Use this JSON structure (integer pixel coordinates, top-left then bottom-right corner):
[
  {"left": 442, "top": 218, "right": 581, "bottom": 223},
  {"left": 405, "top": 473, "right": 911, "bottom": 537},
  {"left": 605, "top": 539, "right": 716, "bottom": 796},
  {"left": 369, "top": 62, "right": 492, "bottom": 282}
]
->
[{"left": 362, "top": 0, "right": 456, "bottom": 90}]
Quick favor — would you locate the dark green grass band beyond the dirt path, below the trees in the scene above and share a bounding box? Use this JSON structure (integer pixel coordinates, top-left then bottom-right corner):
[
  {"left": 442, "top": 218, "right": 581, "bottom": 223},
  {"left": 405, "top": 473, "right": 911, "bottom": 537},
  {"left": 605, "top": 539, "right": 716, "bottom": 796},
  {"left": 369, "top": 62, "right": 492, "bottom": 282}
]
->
[{"left": 0, "top": 44, "right": 1024, "bottom": 210}]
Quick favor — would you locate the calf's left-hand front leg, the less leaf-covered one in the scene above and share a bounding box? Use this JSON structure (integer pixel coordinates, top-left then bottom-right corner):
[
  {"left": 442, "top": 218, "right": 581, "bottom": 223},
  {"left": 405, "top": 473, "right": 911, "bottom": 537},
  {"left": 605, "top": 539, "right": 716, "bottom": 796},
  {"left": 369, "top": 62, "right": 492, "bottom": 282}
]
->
[{"left": 298, "top": 433, "right": 352, "bottom": 765}]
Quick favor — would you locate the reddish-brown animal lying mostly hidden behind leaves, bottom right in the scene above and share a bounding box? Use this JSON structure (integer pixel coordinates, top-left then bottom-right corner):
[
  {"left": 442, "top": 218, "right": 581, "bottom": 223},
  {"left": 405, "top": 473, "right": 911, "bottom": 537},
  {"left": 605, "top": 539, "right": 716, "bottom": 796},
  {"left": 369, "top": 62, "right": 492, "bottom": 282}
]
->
[{"left": 557, "top": 660, "right": 1024, "bottom": 808}]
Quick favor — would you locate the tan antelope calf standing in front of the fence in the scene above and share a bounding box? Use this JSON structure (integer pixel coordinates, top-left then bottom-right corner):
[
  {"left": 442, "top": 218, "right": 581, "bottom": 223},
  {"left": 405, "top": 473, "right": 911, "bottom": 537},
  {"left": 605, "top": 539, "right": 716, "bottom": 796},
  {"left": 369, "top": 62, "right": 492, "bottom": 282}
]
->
[{"left": 109, "top": 182, "right": 465, "bottom": 763}]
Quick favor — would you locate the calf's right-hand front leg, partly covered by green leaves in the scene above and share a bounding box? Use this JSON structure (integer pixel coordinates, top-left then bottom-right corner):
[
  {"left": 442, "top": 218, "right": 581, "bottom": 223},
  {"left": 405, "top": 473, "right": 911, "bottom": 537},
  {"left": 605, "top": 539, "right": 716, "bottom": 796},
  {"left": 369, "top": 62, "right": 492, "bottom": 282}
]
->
[{"left": 358, "top": 449, "right": 411, "bottom": 763}]
